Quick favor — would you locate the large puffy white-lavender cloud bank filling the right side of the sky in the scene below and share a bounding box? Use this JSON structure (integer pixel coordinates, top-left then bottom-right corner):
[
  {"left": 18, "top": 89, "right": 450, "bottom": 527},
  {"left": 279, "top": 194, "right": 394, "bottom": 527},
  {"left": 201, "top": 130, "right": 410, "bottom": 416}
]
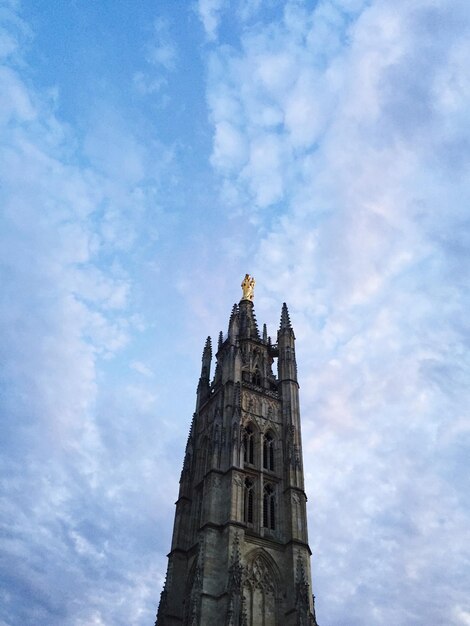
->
[{"left": 208, "top": 0, "right": 470, "bottom": 626}]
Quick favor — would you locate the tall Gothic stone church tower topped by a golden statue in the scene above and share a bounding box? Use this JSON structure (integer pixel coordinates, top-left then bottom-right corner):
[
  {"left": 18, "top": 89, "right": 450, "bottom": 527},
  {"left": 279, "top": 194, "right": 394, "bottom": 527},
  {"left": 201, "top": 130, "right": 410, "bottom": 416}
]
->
[{"left": 156, "top": 274, "right": 317, "bottom": 626}]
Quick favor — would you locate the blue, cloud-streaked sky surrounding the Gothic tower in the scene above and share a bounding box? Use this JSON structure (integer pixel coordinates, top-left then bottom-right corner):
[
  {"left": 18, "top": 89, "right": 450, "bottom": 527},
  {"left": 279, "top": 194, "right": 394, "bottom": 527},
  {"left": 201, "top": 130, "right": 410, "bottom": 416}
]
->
[{"left": 0, "top": 0, "right": 470, "bottom": 626}]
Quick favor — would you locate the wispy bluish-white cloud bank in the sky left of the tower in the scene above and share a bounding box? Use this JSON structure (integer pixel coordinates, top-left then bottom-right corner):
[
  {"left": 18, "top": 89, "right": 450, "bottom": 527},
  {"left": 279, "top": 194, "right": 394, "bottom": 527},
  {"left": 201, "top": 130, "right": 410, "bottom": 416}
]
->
[{"left": 0, "top": 8, "right": 176, "bottom": 625}]
